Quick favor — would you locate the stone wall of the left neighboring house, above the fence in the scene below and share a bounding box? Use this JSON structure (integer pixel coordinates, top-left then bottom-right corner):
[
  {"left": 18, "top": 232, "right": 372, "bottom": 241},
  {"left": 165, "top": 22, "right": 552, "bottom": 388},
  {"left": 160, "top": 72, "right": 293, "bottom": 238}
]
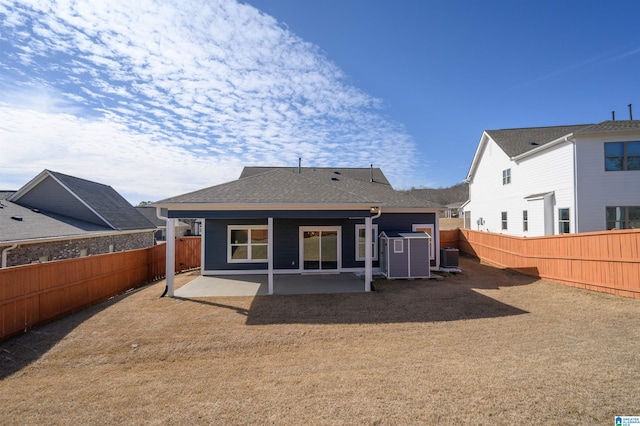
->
[{"left": 0, "top": 231, "right": 155, "bottom": 266}]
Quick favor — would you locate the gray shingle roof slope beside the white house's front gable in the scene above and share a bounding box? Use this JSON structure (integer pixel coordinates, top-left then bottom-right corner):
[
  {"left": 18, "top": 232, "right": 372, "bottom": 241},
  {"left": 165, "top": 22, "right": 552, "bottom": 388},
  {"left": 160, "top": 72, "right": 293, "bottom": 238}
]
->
[{"left": 486, "top": 124, "right": 592, "bottom": 157}]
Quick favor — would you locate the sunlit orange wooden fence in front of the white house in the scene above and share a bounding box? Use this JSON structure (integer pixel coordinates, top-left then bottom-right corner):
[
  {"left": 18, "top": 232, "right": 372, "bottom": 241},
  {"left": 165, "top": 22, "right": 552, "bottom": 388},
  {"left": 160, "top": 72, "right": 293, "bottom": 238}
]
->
[{"left": 459, "top": 229, "right": 640, "bottom": 299}]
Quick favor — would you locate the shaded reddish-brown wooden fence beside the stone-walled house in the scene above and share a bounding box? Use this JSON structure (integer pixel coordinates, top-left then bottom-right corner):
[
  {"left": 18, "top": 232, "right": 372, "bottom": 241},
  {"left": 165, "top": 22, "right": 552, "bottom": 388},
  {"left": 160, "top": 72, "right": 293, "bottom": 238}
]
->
[{"left": 0, "top": 237, "right": 200, "bottom": 339}]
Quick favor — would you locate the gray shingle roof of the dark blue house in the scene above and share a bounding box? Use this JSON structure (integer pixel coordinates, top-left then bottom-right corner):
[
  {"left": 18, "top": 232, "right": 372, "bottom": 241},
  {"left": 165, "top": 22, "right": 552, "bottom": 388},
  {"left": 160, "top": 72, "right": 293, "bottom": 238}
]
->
[{"left": 154, "top": 167, "right": 441, "bottom": 209}]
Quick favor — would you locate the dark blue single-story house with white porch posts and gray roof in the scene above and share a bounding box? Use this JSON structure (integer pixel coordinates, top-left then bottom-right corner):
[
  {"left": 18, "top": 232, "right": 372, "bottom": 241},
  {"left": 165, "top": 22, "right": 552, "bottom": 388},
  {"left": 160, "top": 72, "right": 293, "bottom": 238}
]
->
[{"left": 153, "top": 167, "right": 442, "bottom": 295}]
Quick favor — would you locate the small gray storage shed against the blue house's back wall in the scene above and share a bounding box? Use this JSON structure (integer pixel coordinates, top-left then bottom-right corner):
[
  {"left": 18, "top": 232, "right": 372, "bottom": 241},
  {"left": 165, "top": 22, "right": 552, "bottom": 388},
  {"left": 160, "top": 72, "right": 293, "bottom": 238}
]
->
[{"left": 380, "top": 231, "right": 431, "bottom": 279}]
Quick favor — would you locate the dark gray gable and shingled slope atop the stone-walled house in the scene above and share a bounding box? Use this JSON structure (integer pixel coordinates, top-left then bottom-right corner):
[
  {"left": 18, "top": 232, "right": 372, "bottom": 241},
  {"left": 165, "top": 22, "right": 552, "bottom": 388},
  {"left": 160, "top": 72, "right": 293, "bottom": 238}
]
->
[{"left": 7, "top": 170, "right": 155, "bottom": 231}]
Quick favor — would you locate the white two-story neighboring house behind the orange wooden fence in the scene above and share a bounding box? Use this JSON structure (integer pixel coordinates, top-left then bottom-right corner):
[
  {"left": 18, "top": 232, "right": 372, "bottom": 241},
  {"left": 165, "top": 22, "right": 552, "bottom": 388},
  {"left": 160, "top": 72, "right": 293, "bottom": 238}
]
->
[{"left": 463, "top": 120, "right": 640, "bottom": 236}]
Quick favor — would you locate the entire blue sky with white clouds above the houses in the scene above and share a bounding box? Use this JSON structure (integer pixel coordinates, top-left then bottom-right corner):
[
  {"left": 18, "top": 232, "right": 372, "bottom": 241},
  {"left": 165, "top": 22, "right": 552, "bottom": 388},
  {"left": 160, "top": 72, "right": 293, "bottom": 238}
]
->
[{"left": 0, "top": 0, "right": 640, "bottom": 204}]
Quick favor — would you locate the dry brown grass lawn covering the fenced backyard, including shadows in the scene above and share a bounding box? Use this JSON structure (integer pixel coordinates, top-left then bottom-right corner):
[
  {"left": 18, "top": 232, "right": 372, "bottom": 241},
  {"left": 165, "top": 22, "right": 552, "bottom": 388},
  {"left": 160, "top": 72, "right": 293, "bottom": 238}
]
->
[{"left": 0, "top": 258, "right": 640, "bottom": 425}]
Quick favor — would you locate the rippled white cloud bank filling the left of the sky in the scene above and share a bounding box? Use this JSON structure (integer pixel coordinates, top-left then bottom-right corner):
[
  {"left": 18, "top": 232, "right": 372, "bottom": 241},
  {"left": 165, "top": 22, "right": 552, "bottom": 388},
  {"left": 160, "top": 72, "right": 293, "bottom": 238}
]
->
[{"left": 0, "top": 0, "right": 416, "bottom": 202}]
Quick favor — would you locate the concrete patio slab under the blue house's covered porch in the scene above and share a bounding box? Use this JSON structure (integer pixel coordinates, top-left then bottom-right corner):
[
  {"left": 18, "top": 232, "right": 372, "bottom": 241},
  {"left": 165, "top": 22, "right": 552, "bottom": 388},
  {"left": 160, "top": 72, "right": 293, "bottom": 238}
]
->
[{"left": 175, "top": 273, "right": 364, "bottom": 298}]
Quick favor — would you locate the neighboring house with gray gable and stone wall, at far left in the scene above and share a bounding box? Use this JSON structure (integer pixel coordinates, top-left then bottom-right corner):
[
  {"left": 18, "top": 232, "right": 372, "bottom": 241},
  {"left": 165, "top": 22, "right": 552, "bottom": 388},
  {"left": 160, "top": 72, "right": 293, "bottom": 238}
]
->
[{"left": 0, "top": 170, "right": 156, "bottom": 267}]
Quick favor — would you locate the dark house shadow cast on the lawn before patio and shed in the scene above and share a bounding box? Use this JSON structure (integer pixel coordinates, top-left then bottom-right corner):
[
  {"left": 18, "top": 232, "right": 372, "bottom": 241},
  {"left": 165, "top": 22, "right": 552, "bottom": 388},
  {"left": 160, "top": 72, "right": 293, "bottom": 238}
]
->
[{"left": 247, "top": 259, "right": 537, "bottom": 325}]
